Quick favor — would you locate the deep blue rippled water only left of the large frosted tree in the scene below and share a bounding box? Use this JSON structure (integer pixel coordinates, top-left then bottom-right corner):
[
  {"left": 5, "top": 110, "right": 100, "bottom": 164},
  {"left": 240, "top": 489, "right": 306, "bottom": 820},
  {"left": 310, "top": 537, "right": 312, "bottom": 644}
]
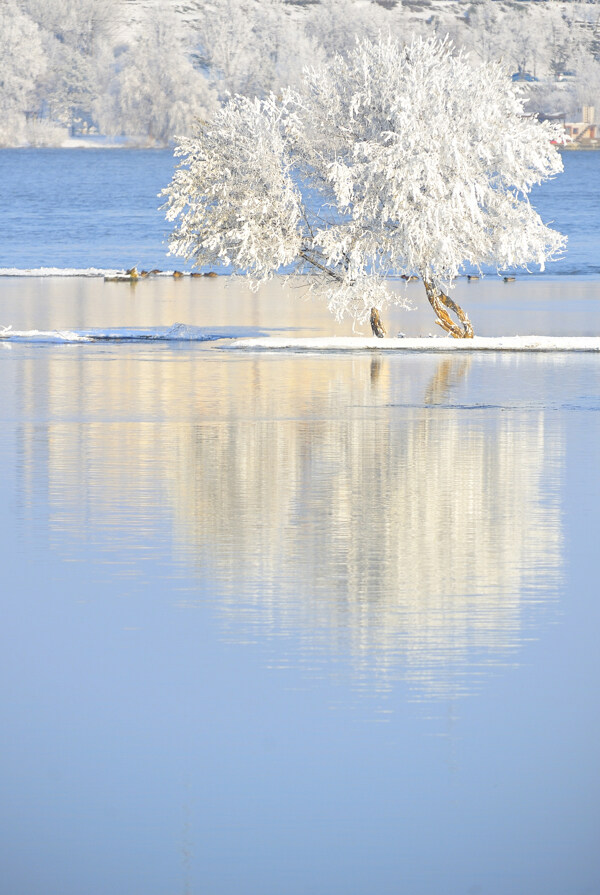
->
[{"left": 0, "top": 149, "right": 183, "bottom": 269}]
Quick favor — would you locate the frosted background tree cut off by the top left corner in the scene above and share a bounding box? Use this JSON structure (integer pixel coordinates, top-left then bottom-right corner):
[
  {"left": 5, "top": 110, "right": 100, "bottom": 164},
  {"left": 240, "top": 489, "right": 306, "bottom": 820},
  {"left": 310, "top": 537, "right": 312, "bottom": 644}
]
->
[{"left": 0, "top": 0, "right": 46, "bottom": 146}]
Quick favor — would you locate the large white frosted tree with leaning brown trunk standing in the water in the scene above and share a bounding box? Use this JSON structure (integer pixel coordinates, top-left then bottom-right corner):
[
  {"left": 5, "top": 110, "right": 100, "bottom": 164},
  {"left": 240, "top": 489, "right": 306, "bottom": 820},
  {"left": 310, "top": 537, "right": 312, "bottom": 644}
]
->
[{"left": 165, "top": 38, "right": 565, "bottom": 337}]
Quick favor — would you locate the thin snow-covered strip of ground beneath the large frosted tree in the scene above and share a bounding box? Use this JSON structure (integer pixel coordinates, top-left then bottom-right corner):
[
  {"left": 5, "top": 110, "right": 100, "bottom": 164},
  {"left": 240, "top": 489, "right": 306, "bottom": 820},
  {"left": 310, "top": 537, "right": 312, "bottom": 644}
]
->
[{"left": 223, "top": 336, "right": 600, "bottom": 351}]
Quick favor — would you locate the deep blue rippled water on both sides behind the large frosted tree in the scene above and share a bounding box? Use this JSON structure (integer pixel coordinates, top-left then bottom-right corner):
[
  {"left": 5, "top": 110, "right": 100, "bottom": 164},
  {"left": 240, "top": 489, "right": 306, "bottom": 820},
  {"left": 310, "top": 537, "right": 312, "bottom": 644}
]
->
[{"left": 0, "top": 149, "right": 600, "bottom": 277}]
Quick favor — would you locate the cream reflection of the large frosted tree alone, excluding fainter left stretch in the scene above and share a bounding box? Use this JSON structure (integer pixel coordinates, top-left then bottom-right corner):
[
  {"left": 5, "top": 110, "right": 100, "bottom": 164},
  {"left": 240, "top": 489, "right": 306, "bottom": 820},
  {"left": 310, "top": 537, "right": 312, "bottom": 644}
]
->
[{"left": 170, "top": 358, "right": 561, "bottom": 692}]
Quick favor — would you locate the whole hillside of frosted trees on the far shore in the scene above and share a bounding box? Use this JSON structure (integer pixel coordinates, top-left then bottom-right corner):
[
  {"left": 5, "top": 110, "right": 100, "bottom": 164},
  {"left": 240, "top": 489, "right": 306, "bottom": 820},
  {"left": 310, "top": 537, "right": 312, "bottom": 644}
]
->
[{"left": 0, "top": 0, "right": 600, "bottom": 146}]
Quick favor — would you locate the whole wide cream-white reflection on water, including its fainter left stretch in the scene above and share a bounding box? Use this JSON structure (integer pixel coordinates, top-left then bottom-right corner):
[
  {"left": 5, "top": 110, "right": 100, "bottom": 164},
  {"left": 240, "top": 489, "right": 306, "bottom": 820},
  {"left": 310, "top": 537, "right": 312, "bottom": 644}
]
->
[{"left": 16, "top": 350, "right": 563, "bottom": 699}]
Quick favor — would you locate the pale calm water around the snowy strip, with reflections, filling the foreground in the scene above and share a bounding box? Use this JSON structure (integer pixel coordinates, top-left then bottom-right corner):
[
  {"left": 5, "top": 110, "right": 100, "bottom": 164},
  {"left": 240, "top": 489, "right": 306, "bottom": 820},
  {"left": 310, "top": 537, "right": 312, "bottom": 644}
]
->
[{"left": 0, "top": 274, "right": 600, "bottom": 895}]
